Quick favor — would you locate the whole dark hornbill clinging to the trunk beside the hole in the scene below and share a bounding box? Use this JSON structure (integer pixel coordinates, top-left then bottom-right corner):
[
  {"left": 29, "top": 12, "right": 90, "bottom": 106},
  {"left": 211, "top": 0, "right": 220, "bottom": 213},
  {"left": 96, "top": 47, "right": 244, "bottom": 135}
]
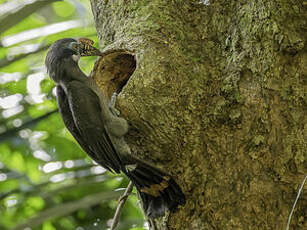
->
[{"left": 45, "top": 38, "right": 185, "bottom": 218}]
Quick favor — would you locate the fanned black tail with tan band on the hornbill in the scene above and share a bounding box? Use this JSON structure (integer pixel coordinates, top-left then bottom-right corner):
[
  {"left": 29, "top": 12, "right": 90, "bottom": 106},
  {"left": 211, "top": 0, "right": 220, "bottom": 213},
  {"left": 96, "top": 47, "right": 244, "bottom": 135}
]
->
[{"left": 123, "top": 156, "right": 185, "bottom": 218}]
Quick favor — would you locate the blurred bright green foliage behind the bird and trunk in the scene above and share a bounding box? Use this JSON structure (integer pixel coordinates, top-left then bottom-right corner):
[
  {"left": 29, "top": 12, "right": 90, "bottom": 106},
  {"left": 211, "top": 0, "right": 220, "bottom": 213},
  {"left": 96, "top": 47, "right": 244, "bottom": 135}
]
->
[{"left": 0, "top": 0, "right": 146, "bottom": 230}]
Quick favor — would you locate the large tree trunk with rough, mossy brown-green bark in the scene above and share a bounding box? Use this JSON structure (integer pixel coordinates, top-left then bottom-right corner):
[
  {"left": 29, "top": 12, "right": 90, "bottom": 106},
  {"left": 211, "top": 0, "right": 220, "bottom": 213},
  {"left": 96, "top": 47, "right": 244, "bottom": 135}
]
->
[{"left": 91, "top": 0, "right": 307, "bottom": 230}]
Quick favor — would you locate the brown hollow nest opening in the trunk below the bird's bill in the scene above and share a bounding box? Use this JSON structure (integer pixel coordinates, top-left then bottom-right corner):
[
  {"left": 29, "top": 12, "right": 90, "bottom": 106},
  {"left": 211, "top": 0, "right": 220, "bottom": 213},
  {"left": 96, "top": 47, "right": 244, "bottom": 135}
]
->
[{"left": 92, "top": 50, "right": 136, "bottom": 99}]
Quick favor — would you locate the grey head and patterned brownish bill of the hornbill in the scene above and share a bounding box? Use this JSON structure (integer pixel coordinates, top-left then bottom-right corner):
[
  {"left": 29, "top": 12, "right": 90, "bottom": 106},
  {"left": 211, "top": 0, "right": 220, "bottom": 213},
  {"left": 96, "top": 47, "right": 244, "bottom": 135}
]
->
[{"left": 45, "top": 38, "right": 102, "bottom": 80}]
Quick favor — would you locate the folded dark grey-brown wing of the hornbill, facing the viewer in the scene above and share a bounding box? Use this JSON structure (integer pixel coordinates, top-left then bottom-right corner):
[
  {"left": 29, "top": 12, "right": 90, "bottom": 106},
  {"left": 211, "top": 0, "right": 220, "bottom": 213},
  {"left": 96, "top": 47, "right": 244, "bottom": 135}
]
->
[{"left": 66, "top": 81, "right": 121, "bottom": 172}]
